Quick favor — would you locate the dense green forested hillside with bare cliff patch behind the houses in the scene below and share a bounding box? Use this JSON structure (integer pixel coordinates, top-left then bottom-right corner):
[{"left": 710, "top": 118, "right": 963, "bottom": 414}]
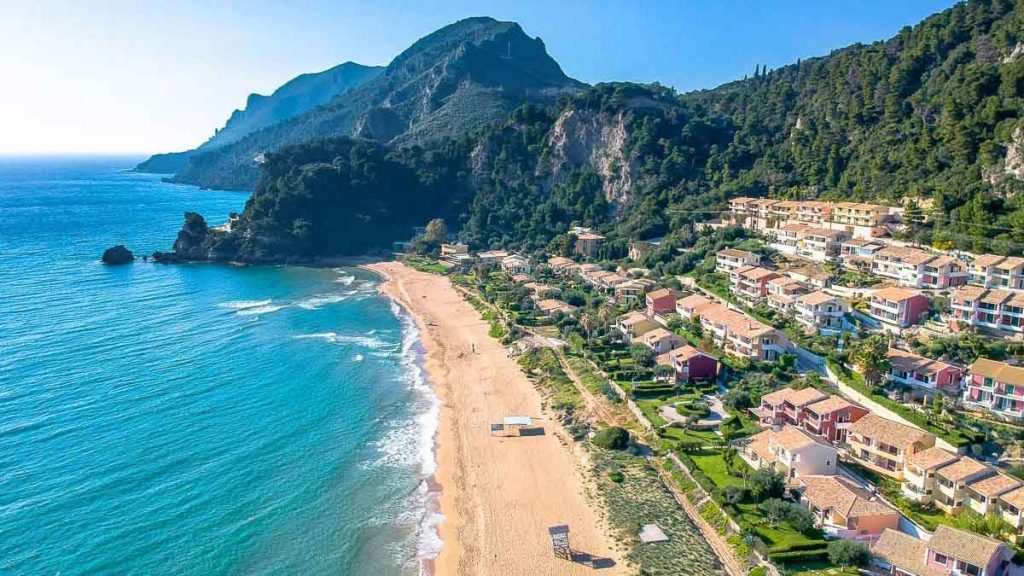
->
[{"left": 159, "top": 0, "right": 1024, "bottom": 261}]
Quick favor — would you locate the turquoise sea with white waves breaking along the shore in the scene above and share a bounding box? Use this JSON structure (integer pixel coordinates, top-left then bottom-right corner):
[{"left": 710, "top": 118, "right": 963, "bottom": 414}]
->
[{"left": 0, "top": 158, "right": 437, "bottom": 575}]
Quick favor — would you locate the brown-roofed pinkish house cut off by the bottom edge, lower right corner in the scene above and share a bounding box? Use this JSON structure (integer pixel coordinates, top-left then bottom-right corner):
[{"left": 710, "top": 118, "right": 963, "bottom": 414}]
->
[{"left": 871, "top": 525, "right": 1014, "bottom": 576}]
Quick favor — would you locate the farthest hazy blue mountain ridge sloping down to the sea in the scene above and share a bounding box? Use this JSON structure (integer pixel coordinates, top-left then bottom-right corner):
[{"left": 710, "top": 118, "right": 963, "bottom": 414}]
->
[{"left": 135, "top": 61, "right": 384, "bottom": 174}]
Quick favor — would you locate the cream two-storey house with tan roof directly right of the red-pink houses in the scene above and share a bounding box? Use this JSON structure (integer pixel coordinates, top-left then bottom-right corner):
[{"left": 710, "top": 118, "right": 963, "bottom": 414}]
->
[{"left": 846, "top": 414, "right": 935, "bottom": 480}]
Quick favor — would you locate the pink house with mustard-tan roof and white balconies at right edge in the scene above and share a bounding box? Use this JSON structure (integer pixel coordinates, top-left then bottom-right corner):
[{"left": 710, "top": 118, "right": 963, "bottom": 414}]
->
[{"left": 964, "top": 358, "right": 1024, "bottom": 420}]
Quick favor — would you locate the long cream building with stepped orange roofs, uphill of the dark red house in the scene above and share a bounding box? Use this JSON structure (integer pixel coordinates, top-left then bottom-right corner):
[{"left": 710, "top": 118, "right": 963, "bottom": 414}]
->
[{"left": 676, "top": 294, "right": 790, "bottom": 361}]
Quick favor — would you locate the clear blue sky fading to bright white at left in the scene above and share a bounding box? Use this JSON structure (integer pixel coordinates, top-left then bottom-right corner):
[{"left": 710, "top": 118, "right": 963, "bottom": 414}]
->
[{"left": 0, "top": 0, "right": 953, "bottom": 154}]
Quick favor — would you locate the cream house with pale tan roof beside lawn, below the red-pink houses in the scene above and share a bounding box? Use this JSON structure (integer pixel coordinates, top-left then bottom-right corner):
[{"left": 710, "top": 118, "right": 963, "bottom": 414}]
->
[{"left": 739, "top": 425, "right": 839, "bottom": 480}]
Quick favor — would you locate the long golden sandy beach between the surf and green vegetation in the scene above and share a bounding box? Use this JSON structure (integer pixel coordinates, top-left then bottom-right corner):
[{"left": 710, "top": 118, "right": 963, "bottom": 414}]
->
[{"left": 366, "top": 262, "right": 626, "bottom": 576}]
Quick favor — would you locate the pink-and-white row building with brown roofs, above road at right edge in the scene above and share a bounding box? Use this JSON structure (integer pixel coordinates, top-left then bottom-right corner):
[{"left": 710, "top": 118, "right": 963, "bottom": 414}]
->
[{"left": 949, "top": 286, "right": 1024, "bottom": 336}]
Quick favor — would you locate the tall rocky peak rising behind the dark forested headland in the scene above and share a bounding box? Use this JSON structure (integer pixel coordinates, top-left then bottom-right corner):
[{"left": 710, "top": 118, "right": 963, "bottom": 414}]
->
[{"left": 167, "top": 17, "right": 585, "bottom": 190}]
